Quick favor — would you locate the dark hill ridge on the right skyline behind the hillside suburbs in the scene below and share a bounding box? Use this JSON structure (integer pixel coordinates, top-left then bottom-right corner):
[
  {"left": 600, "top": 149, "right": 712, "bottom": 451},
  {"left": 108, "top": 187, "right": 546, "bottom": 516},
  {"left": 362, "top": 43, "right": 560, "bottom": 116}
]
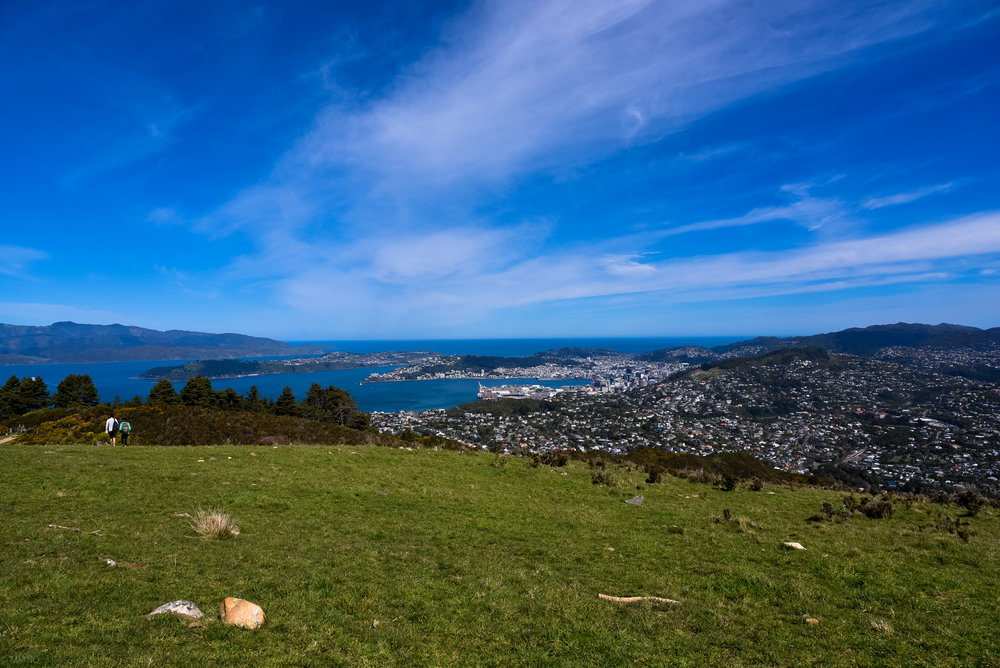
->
[{"left": 639, "top": 322, "right": 1000, "bottom": 363}]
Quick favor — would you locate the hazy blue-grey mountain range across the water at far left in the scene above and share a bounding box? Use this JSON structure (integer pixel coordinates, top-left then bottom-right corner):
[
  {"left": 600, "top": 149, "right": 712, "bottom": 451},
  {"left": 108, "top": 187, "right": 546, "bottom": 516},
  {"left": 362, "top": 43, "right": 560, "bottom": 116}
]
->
[{"left": 0, "top": 322, "right": 322, "bottom": 364}]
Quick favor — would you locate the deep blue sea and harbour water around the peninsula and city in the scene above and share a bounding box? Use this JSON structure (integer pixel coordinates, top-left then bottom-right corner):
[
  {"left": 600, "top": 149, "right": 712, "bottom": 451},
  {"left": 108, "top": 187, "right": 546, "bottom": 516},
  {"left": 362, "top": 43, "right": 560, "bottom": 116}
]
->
[{"left": 0, "top": 337, "right": 749, "bottom": 412}]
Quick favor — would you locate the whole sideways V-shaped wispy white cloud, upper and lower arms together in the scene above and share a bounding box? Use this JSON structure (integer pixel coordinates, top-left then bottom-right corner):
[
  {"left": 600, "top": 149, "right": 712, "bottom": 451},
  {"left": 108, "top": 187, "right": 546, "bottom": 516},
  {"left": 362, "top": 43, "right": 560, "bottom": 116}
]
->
[{"left": 186, "top": 0, "right": 1000, "bottom": 331}]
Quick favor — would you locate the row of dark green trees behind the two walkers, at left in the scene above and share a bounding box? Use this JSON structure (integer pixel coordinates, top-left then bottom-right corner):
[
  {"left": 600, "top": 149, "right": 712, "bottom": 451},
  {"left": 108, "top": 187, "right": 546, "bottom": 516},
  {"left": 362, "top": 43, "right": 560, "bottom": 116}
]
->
[{"left": 0, "top": 374, "right": 370, "bottom": 429}]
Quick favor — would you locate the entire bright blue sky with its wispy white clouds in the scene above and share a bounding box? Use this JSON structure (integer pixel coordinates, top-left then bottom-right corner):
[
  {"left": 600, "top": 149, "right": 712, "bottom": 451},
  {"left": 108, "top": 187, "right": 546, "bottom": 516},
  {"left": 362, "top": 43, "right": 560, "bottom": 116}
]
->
[{"left": 0, "top": 0, "right": 1000, "bottom": 340}]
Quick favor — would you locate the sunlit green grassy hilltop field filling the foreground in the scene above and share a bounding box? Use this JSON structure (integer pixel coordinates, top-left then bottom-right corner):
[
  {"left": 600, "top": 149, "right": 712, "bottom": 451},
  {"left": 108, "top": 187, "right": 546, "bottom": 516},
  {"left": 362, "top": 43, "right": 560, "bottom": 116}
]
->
[{"left": 0, "top": 445, "right": 1000, "bottom": 666}]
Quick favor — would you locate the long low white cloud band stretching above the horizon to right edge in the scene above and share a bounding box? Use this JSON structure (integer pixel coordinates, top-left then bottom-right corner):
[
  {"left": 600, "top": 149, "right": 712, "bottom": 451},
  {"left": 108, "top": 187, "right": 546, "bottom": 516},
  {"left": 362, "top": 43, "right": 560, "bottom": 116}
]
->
[{"left": 268, "top": 213, "right": 1000, "bottom": 326}]
